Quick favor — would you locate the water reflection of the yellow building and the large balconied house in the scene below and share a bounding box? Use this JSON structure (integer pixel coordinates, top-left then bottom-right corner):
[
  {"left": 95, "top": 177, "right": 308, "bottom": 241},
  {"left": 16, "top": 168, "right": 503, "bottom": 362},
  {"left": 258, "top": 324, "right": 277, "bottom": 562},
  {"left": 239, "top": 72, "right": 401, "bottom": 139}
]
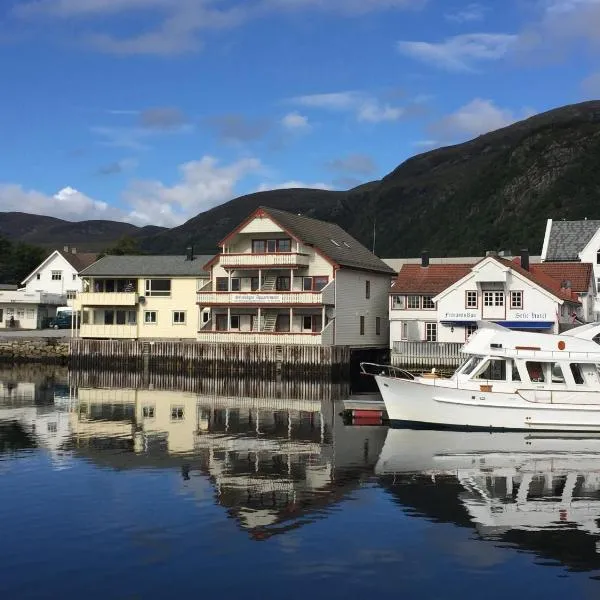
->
[{"left": 71, "top": 379, "right": 386, "bottom": 539}]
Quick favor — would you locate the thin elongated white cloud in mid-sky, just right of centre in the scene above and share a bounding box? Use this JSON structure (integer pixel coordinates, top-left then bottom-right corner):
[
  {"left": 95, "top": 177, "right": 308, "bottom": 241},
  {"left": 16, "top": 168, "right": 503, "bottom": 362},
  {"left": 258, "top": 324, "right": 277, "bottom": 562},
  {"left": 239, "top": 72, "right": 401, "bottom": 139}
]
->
[{"left": 291, "top": 90, "right": 405, "bottom": 123}]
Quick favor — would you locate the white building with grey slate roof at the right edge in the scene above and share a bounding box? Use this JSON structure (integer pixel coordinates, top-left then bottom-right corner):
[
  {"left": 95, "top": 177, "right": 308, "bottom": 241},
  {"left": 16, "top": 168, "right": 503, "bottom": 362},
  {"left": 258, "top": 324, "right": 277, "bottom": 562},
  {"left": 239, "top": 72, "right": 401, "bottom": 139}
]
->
[{"left": 542, "top": 219, "right": 600, "bottom": 320}]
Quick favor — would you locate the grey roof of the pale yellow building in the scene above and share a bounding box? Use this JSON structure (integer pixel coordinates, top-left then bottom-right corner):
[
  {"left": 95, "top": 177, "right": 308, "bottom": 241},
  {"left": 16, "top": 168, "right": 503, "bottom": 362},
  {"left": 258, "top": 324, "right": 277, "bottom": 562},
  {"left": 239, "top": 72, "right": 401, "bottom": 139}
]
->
[{"left": 79, "top": 254, "right": 213, "bottom": 277}]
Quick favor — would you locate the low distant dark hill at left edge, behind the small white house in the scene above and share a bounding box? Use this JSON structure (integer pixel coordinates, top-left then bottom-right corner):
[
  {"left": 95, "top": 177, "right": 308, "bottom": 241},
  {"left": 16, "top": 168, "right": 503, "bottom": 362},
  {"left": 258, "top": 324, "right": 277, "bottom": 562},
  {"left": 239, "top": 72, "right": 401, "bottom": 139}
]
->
[{"left": 0, "top": 212, "right": 164, "bottom": 251}]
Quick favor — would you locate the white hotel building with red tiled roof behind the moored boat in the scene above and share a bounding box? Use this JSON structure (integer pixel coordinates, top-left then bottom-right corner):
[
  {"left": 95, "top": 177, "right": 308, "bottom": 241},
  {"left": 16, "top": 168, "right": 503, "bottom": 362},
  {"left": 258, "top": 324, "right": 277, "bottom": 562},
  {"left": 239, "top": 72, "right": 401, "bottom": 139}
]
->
[{"left": 390, "top": 254, "right": 596, "bottom": 351}]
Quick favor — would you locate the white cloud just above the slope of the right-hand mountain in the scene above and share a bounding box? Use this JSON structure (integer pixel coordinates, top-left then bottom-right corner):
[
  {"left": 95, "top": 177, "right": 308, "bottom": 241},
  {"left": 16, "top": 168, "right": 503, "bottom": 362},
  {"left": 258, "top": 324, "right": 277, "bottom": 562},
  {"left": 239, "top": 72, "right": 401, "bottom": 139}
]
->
[{"left": 430, "top": 98, "right": 533, "bottom": 139}]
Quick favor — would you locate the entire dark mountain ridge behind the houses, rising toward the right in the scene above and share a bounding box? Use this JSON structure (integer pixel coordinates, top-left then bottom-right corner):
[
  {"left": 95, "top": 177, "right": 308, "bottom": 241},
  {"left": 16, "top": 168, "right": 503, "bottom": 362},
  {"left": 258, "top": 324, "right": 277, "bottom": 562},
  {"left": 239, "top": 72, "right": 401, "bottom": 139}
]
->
[{"left": 0, "top": 101, "right": 600, "bottom": 257}]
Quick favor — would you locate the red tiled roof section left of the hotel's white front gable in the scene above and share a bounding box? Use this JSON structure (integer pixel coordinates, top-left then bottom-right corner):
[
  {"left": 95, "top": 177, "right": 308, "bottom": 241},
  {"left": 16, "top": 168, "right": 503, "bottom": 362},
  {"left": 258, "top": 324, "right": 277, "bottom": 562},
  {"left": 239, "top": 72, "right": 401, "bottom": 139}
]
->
[{"left": 392, "top": 264, "right": 473, "bottom": 294}]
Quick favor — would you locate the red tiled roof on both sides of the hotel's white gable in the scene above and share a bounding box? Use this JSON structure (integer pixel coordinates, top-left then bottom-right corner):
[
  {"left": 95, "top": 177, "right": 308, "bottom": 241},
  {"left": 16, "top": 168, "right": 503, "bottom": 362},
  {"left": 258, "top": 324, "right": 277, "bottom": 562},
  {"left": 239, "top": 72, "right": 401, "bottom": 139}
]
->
[{"left": 391, "top": 256, "right": 592, "bottom": 302}]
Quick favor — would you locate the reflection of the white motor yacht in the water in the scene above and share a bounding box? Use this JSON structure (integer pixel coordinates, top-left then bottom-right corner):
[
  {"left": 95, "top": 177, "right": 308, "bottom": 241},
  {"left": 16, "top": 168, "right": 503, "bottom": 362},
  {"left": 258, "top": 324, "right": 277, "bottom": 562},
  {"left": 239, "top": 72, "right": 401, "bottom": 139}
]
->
[{"left": 375, "top": 429, "right": 600, "bottom": 569}]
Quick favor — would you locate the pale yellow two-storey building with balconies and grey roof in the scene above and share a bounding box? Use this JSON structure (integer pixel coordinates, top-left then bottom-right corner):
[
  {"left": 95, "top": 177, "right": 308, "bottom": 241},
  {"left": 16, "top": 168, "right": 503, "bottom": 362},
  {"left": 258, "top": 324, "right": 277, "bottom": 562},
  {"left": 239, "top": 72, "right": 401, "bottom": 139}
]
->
[{"left": 76, "top": 249, "right": 212, "bottom": 340}]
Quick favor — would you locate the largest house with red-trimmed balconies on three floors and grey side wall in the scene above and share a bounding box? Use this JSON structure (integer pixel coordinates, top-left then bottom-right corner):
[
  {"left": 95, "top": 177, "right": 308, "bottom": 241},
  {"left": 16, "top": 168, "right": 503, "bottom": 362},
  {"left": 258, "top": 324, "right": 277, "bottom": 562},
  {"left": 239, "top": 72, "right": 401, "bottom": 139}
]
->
[{"left": 197, "top": 207, "right": 394, "bottom": 347}]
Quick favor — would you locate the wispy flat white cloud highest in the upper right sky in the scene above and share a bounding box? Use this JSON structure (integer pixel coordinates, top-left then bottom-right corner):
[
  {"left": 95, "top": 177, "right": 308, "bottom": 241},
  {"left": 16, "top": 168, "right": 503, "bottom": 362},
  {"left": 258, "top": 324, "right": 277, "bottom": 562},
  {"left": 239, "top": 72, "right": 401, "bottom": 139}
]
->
[{"left": 397, "top": 33, "right": 518, "bottom": 71}]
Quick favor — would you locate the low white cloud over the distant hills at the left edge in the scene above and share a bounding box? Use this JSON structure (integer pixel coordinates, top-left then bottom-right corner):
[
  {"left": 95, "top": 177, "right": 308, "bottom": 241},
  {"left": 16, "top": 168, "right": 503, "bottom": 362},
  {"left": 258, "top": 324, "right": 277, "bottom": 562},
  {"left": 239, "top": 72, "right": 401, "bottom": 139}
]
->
[{"left": 0, "top": 183, "right": 115, "bottom": 221}]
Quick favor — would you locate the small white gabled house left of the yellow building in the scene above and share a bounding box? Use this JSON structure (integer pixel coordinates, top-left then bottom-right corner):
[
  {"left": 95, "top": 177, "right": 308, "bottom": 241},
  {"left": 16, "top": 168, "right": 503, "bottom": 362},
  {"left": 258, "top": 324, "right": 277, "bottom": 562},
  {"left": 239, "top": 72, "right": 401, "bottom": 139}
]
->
[{"left": 21, "top": 246, "right": 97, "bottom": 306}]
